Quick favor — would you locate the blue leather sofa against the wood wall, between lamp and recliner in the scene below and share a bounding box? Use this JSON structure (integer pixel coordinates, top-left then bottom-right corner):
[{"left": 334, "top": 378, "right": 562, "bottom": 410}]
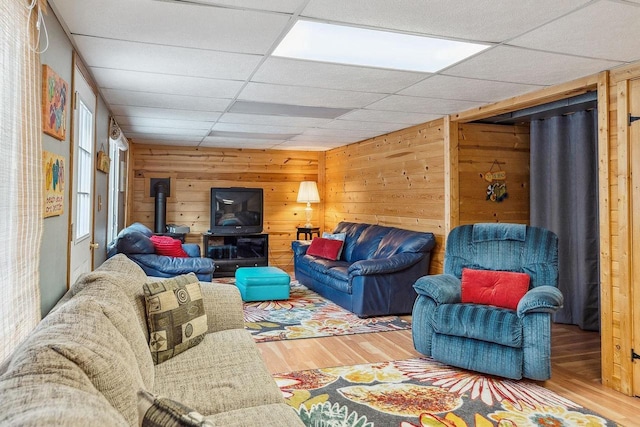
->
[{"left": 292, "top": 222, "right": 435, "bottom": 317}]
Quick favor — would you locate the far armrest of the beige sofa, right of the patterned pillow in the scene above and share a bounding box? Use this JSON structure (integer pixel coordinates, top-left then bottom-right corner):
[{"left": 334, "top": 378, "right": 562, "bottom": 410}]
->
[{"left": 200, "top": 282, "right": 244, "bottom": 332}]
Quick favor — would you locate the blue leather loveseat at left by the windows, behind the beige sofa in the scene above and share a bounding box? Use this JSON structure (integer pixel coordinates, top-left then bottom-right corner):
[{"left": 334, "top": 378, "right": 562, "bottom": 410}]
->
[{"left": 107, "top": 222, "right": 214, "bottom": 282}]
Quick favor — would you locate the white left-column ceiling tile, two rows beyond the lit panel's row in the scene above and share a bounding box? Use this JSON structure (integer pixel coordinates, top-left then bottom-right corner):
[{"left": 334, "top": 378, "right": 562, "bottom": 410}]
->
[{"left": 91, "top": 68, "right": 242, "bottom": 98}]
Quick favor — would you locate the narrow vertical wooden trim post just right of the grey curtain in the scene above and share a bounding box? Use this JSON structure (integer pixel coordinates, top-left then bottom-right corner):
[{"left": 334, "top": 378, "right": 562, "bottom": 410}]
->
[{"left": 598, "top": 71, "right": 614, "bottom": 387}]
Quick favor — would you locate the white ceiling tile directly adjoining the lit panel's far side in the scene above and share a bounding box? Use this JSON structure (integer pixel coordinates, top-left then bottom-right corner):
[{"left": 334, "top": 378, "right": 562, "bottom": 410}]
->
[{"left": 251, "top": 57, "right": 428, "bottom": 93}]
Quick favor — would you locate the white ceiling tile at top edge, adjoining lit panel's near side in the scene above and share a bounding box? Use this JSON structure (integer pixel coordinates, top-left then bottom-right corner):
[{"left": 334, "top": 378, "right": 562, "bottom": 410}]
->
[{"left": 301, "top": 0, "right": 589, "bottom": 42}]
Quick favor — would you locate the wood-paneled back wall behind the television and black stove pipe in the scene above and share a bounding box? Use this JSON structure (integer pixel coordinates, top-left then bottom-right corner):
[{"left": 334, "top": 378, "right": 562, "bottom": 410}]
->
[{"left": 127, "top": 143, "right": 324, "bottom": 272}]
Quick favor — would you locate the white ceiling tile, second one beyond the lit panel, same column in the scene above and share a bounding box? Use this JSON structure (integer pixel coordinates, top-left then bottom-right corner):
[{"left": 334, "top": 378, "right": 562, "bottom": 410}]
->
[{"left": 238, "top": 83, "right": 384, "bottom": 108}]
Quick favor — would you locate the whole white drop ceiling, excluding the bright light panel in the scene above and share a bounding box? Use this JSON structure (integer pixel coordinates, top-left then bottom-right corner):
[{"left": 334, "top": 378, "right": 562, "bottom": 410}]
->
[{"left": 49, "top": 0, "right": 640, "bottom": 151}]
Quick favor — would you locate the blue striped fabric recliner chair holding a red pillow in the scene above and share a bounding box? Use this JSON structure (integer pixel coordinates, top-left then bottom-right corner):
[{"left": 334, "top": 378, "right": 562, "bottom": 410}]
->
[{"left": 412, "top": 223, "right": 563, "bottom": 380}]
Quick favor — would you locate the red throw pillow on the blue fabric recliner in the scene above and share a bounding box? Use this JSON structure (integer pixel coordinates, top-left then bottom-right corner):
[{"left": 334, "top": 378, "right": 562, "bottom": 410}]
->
[{"left": 462, "top": 268, "right": 531, "bottom": 310}]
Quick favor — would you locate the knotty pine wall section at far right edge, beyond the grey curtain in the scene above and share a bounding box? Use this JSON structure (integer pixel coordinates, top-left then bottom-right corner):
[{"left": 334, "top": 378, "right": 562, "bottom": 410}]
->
[{"left": 598, "top": 64, "right": 640, "bottom": 395}]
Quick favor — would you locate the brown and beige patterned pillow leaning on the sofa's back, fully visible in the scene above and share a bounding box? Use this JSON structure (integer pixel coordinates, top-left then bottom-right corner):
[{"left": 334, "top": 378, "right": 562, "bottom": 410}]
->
[{"left": 143, "top": 273, "right": 207, "bottom": 365}]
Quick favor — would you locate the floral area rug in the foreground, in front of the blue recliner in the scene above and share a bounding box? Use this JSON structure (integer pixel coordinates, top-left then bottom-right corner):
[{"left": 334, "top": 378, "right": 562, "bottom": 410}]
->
[{"left": 274, "top": 358, "right": 616, "bottom": 427}]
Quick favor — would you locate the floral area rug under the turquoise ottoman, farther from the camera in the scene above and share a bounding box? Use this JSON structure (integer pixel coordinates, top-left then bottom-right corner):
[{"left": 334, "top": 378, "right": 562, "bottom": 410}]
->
[{"left": 214, "top": 278, "right": 411, "bottom": 342}]
